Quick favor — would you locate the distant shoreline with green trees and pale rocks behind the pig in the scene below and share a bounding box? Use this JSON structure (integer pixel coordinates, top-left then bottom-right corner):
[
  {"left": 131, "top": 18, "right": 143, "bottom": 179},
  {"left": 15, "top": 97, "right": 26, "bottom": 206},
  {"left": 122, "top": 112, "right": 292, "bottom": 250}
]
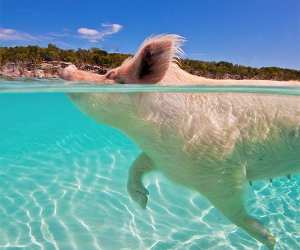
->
[{"left": 0, "top": 44, "right": 300, "bottom": 82}]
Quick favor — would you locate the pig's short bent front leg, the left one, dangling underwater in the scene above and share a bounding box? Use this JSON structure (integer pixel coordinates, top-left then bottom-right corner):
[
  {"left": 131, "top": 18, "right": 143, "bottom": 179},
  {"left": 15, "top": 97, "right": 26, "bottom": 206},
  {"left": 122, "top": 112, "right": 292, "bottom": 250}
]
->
[{"left": 127, "top": 153, "right": 154, "bottom": 209}]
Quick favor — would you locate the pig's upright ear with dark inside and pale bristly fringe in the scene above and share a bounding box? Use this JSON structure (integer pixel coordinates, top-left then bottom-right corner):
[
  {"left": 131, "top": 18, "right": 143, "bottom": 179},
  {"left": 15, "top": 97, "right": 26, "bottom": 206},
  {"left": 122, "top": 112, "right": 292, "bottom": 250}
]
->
[{"left": 120, "top": 35, "right": 184, "bottom": 83}]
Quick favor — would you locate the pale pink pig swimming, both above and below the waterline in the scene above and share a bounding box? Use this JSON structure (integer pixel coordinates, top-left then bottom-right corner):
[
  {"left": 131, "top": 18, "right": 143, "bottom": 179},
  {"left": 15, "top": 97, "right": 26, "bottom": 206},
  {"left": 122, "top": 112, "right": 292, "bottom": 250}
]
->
[{"left": 61, "top": 35, "right": 300, "bottom": 249}]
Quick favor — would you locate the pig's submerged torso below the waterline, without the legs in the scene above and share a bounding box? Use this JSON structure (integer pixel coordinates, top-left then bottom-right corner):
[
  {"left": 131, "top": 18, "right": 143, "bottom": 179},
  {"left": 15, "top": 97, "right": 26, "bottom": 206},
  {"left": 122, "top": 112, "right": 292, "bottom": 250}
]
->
[{"left": 72, "top": 90, "right": 300, "bottom": 182}]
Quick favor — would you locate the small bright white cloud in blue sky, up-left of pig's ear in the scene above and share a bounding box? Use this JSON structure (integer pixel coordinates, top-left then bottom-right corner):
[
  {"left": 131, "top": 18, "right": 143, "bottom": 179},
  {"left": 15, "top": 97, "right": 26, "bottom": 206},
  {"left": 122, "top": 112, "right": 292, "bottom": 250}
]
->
[{"left": 77, "top": 23, "right": 123, "bottom": 42}]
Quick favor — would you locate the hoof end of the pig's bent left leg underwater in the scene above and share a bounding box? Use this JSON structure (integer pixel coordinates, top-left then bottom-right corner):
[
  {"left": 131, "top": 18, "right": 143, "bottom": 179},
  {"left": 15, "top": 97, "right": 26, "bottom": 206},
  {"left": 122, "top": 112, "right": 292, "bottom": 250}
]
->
[{"left": 127, "top": 181, "right": 149, "bottom": 209}]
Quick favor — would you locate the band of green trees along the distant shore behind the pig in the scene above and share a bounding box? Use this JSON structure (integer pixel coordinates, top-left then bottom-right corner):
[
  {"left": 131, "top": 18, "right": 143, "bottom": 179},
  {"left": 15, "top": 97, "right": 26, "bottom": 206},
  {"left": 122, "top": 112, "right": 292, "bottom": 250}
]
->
[{"left": 0, "top": 44, "right": 300, "bottom": 81}]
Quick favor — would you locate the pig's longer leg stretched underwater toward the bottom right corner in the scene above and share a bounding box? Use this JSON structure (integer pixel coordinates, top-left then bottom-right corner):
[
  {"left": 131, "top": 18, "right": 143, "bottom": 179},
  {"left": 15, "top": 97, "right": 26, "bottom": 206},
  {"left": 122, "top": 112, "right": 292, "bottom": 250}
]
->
[{"left": 205, "top": 166, "right": 275, "bottom": 249}]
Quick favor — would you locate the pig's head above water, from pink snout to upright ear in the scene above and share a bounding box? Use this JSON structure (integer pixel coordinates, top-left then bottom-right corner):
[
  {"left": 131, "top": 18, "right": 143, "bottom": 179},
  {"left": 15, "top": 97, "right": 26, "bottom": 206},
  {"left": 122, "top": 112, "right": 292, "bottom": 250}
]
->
[{"left": 61, "top": 35, "right": 183, "bottom": 84}]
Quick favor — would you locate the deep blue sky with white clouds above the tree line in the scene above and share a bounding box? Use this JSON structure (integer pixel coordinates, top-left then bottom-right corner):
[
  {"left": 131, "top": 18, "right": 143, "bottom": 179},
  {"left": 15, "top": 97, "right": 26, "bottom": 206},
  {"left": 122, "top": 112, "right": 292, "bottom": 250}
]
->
[{"left": 0, "top": 0, "right": 300, "bottom": 69}]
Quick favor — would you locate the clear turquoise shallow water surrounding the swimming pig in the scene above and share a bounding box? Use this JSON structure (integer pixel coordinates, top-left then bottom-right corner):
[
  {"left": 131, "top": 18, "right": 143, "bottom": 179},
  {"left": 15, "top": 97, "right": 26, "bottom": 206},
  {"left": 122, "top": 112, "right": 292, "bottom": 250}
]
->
[{"left": 0, "top": 82, "right": 300, "bottom": 249}]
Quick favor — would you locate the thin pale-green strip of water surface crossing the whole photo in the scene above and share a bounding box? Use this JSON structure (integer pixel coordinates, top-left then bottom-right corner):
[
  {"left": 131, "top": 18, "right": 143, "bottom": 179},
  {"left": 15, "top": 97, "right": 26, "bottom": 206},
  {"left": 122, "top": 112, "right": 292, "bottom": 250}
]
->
[{"left": 0, "top": 79, "right": 300, "bottom": 95}]
